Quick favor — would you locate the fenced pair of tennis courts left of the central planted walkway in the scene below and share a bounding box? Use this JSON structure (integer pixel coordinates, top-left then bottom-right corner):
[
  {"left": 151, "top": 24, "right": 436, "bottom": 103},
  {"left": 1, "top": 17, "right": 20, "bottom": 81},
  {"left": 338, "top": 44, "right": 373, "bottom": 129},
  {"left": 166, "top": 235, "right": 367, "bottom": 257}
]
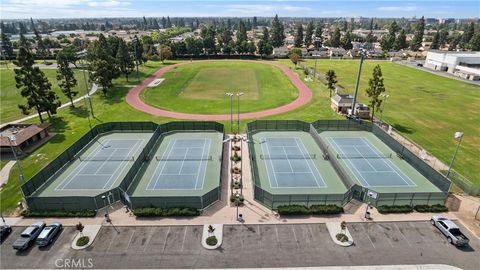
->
[{"left": 22, "top": 122, "right": 223, "bottom": 210}]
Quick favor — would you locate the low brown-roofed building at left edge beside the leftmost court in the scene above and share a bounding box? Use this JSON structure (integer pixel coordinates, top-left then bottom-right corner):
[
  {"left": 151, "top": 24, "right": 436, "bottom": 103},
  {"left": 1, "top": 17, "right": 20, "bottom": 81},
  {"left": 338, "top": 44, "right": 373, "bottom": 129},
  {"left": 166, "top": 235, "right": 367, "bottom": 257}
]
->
[{"left": 0, "top": 124, "right": 50, "bottom": 156}]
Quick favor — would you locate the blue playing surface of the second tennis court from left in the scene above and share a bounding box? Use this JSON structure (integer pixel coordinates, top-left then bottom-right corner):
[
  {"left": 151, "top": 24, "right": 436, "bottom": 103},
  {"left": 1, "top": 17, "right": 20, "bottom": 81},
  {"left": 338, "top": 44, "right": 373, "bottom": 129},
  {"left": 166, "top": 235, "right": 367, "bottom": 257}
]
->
[{"left": 147, "top": 138, "right": 212, "bottom": 190}]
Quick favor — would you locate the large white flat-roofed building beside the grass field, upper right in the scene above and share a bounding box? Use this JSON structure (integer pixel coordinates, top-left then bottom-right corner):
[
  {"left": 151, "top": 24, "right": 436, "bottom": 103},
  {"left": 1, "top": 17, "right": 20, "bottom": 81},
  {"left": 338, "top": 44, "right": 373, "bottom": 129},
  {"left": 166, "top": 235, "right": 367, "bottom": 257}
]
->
[{"left": 424, "top": 51, "right": 480, "bottom": 80}]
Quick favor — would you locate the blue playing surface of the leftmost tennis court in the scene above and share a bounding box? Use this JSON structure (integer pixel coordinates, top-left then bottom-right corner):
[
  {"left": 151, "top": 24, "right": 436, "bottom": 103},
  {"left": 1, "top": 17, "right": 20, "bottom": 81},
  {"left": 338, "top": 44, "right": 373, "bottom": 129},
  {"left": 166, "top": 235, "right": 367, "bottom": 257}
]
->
[{"left": 55, "top": 139, "right": 144, "bottom": 191}]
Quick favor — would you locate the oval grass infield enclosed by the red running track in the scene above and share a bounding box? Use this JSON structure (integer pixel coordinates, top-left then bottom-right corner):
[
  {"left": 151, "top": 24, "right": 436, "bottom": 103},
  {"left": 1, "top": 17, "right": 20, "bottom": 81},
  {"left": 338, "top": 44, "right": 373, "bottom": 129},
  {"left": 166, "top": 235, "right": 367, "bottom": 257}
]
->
[{"left": 141, "top": 61, "right": 298, "bottom": 114}]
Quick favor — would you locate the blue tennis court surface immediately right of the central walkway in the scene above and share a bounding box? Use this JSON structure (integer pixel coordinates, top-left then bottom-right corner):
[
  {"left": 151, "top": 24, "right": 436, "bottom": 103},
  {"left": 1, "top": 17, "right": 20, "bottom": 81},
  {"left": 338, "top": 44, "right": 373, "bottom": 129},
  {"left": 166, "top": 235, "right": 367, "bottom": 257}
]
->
[{"left": 260, "top": 138, "right": 326, "bottom": 188}]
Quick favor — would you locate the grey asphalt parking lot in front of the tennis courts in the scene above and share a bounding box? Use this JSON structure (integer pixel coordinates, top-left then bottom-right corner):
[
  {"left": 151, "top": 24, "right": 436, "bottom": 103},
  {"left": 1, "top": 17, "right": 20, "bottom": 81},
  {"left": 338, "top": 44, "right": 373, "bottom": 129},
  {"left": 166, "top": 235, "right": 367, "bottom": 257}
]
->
[{"left": 1, "top": 221, "right": 480, "bottom": 269}]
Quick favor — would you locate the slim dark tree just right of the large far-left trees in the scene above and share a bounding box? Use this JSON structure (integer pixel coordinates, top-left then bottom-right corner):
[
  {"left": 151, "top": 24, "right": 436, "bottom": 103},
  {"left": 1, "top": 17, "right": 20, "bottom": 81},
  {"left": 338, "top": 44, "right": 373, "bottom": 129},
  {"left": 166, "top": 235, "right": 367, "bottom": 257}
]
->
[{"left": 57, "top": 48, "right": 78, "bottom": 108}]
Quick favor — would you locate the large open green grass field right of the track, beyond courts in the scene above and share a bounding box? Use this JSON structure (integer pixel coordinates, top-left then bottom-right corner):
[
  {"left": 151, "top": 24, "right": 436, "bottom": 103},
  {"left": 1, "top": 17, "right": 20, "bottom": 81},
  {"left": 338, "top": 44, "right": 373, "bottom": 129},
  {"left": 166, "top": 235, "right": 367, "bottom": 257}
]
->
[{"left": 307, "top": 60, "right": 480, "bottom": 185}]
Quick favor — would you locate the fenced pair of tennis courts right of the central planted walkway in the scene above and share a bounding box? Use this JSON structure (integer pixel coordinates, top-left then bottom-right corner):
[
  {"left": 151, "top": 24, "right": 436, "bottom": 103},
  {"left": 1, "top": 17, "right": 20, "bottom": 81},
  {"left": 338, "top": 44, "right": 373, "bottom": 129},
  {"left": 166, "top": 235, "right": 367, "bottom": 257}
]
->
[{"left": 247, "top": 120, "right": 451, "bottom": 208}]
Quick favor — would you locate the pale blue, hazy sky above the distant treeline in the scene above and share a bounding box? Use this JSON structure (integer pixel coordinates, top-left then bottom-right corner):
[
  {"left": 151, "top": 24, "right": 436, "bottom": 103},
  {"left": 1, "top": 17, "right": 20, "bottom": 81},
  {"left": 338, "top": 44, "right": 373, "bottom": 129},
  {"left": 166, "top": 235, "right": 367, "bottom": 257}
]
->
[{"left": 0, "top": 0, "right": 480, "bottom": 19}]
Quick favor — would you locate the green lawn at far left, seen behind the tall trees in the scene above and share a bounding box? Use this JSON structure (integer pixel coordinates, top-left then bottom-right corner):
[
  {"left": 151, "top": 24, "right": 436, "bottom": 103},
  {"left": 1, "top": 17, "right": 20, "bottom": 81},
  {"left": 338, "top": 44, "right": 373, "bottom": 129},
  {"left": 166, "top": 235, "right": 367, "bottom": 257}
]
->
[{"left": 0, "top": 69, "right": 86, "bottom": 123}]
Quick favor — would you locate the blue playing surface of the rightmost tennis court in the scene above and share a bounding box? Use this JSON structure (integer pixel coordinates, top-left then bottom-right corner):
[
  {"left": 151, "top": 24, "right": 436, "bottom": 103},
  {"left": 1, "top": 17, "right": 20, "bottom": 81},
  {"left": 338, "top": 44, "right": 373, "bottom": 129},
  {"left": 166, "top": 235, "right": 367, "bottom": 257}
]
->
[{"left": 327, "top": 137, "right": 416, "bottom": 187}]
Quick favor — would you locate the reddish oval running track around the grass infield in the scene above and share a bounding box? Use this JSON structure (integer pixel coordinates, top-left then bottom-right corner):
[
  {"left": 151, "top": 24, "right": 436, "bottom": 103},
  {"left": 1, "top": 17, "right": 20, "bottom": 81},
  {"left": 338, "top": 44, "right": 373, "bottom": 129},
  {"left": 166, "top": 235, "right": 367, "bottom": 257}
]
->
[{"left": 126, "top": 60, "right": 312, "bottom": 121}]
